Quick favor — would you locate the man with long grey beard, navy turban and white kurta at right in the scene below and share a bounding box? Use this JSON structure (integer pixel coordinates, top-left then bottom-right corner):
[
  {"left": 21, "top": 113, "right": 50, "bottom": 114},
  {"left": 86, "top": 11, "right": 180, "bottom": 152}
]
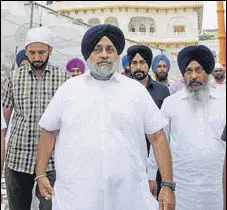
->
[{"left": 150, "top": 45, "right": 226, "bottom": 210}]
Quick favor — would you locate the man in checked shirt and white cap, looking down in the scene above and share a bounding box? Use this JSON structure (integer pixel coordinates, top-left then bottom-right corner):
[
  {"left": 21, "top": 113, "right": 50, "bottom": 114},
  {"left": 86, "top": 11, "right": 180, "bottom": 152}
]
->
[{"left": 2, "top": 27, "right": 71, "bottom": 210}]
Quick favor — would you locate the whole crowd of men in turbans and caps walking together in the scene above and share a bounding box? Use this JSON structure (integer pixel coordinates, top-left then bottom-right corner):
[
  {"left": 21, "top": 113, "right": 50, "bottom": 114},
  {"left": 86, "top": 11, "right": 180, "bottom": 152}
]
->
[{"left": 1, "top": 24, "right": 226, "bottom": 210}]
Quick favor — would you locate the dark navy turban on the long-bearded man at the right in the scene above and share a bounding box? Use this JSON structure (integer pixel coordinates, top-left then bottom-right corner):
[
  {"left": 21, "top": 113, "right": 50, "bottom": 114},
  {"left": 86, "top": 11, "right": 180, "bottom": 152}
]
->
[{"left": 177, "top": 45, "right": 215, "bottom": 76}]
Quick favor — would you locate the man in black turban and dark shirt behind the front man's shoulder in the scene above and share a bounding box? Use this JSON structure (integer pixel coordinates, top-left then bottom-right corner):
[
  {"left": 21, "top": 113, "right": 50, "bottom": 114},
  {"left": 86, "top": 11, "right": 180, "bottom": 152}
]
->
[{"left": 127, "top": 45, "right": 170, "bottom": 196}]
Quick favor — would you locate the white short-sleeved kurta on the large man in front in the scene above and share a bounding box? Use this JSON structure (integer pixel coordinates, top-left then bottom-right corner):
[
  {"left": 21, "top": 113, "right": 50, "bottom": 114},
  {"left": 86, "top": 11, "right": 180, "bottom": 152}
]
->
[{"left": 39, "top": 73, "right": 167, "bottom": 210}]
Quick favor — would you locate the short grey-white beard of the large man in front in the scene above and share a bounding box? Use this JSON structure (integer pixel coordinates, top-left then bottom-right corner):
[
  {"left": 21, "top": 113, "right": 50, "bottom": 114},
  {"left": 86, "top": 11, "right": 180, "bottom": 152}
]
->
[{"left": 87, "top": 58, "right": 120, "bottom": 80}]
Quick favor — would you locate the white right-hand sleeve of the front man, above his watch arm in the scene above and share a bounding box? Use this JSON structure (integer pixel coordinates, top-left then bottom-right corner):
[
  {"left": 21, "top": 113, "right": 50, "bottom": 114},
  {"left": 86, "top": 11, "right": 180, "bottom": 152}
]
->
[{"left": 143, "top": 90, "right": 168, "bottom": 134}]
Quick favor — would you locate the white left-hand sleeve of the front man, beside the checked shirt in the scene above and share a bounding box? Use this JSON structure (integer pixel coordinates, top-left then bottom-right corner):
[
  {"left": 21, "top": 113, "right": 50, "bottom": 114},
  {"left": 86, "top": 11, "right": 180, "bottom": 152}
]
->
[{"left": 39, "top": 86, "right": 64, "bottom": 131}]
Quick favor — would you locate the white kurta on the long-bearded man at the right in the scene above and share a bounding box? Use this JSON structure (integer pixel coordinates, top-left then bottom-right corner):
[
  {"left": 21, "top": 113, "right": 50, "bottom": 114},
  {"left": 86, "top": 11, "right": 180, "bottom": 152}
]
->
[{"left": 161, "top": 88, "right": 226, "bottom": 210}]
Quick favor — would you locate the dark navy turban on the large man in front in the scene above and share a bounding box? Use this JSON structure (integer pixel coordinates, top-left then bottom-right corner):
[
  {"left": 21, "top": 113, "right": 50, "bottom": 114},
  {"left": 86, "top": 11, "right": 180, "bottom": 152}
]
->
[{"left": 81, "top": 24, "right": 125, "bottom": 60}]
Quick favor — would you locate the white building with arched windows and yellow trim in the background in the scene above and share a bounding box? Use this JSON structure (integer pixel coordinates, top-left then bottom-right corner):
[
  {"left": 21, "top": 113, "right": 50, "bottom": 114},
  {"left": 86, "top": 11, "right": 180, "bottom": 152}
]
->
[{"left": 47, "top": 1, "right": 203, "bottom": 53}]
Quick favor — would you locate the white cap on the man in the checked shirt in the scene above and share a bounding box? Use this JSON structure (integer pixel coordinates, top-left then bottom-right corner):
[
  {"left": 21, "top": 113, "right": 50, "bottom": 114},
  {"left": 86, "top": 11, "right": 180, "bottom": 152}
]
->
[{"left": 25, "top": 27, "right": 54, "bottom": 47}]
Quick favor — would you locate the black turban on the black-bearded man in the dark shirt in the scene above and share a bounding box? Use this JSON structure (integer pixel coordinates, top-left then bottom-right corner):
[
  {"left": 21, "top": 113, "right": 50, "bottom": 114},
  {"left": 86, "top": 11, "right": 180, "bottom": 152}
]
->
[{"left": 127, "top": 45, "right": 153, "bottom": 69}]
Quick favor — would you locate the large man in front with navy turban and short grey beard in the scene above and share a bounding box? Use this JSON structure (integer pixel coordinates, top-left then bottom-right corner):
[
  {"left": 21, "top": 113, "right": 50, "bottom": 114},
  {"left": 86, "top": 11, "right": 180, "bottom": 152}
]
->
[{"left": 37, "top": 22, "right": 175, "bottom": 210}]
